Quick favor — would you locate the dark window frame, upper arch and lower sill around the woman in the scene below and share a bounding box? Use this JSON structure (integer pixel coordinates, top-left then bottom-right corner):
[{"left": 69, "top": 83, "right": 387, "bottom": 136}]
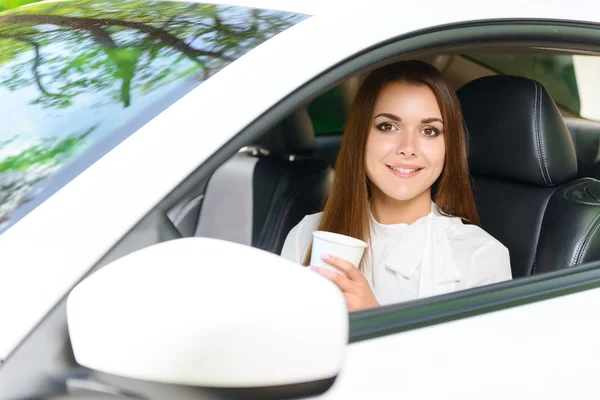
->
[{"left": 157, "top": 20, "right": 600, "bottom": 343}]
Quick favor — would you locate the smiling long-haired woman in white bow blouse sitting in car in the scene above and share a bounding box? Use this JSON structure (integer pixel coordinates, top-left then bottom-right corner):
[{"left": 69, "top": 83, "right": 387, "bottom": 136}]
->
[{"left": 282, "top": 61, "right": 512, "bottom": 311}]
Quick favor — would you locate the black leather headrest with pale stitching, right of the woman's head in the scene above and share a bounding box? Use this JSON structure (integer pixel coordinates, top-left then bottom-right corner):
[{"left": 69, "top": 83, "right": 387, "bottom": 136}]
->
[{"left": 457, "top": 75, "right": 577, "bottom": 186}]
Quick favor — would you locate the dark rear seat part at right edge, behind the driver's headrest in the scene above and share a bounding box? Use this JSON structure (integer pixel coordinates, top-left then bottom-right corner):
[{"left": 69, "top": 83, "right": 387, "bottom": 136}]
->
[{"left": 564, "top": 118, "right": 600, "bottom": 179}]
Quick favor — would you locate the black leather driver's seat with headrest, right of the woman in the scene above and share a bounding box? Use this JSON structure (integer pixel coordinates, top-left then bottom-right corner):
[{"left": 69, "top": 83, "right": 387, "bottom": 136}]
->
[{"left": 457, "top": 76, "right": 600, "bottom": 278}]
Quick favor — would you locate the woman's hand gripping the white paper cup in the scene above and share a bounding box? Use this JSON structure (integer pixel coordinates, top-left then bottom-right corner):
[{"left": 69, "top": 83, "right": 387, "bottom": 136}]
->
[{"left": 311, "top": 255, "right": 379, "bottom": 311}]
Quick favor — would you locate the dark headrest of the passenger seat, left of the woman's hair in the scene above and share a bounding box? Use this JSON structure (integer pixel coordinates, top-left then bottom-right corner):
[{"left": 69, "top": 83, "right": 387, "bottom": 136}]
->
[{"left": 252, "top": 109, "right": 316, "bottom": 155}]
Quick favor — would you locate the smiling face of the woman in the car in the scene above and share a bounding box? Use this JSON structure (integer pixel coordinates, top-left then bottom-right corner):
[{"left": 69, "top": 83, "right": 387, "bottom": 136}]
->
[{"left": 365, "top": 82, "right": 446, "bottom": 201}]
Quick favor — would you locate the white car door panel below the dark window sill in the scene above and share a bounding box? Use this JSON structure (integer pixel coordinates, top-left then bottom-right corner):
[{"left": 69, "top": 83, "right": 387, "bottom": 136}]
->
[{"left": 315, "top": 282, "right": 600, "bottom": 400}]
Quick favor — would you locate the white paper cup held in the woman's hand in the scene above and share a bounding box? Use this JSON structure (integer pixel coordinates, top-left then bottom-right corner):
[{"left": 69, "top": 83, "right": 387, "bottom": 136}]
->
[{"left": 310, "top": 231, "right": 367, "bottom": 273}]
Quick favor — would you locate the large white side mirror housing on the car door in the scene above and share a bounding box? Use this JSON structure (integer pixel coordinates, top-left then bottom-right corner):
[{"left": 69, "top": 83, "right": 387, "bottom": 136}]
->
[{"left": 67, "top": 238, "right": 348, "bottom": 392}]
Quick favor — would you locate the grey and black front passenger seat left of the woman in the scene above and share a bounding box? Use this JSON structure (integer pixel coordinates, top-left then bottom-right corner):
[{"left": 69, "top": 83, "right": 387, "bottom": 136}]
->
[{"left": 193, "top": 110, "right": 333, "bottom": 254}]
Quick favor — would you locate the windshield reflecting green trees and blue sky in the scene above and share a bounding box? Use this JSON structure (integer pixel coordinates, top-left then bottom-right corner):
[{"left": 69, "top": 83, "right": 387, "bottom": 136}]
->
[{"left": 0, "top": 0, "right": 307, "bottom": 232}]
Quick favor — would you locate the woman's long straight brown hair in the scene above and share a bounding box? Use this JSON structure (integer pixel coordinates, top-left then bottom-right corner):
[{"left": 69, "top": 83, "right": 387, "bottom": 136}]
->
[{"left": 304, "top": 60, "right": 479, "bottom": 272}]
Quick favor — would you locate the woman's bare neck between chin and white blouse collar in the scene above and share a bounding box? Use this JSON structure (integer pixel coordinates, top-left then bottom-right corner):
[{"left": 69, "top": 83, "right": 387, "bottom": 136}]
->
[{"left": 371, "top": 189, "right": 431, "bottom": 225}]
